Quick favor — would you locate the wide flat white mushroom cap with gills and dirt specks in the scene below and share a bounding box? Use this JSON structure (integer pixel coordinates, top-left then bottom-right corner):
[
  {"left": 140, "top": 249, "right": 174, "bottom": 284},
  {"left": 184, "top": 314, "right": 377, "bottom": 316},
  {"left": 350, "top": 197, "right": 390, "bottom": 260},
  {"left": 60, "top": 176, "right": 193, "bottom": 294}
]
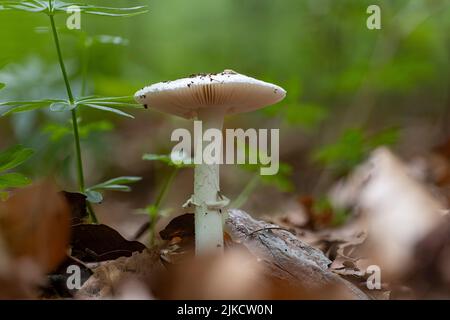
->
[{"left": 134, "top": 70, "right": 286, "bottom": 119}]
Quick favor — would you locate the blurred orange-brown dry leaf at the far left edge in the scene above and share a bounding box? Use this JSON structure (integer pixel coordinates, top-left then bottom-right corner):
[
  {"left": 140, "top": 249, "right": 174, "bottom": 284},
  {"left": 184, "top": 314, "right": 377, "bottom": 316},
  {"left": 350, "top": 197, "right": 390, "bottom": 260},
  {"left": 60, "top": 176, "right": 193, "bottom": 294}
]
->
[{"left": 0, "top": 183, "right": 70, "bottom": 272}]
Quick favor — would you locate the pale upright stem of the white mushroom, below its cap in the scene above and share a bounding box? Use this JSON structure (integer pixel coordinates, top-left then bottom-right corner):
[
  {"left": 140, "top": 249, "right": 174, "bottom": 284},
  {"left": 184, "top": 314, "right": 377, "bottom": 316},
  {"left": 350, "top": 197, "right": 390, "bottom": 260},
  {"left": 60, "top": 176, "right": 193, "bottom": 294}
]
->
[{"left": 193, "top": 108, "right": 224, "bottom": 255}]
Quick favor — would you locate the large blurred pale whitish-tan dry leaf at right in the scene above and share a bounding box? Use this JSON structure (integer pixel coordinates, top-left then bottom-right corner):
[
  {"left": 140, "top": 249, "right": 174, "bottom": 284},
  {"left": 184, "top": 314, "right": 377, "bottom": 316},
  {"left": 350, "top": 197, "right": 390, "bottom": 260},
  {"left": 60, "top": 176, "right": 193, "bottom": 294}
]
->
[{"left": 330, "top": 148, "right": 443, "bottom": 279}]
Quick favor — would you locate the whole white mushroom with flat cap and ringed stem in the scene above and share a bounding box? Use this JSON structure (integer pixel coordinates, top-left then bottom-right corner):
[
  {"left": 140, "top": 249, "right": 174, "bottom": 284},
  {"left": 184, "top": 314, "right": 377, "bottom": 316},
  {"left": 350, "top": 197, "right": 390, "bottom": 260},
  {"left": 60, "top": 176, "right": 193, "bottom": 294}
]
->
[{"left": 135, "top": 70, "right": 286, "bottom": 254}]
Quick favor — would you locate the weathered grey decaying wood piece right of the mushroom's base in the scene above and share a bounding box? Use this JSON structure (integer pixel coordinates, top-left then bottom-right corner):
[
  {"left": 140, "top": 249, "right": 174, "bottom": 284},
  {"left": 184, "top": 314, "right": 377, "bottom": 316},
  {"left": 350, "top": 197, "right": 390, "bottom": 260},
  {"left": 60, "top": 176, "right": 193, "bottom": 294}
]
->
[{"left": 226, "top": 210, "right": 368, "bottom": 299}]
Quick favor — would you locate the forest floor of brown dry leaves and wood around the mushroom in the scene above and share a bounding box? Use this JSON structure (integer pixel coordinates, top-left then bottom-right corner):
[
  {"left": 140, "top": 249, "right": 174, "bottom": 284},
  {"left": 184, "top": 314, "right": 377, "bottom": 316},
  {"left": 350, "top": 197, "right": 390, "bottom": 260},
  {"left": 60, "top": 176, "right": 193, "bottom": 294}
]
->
[{"left": 0, "top": 141, "right": 450, "bottom": 299}]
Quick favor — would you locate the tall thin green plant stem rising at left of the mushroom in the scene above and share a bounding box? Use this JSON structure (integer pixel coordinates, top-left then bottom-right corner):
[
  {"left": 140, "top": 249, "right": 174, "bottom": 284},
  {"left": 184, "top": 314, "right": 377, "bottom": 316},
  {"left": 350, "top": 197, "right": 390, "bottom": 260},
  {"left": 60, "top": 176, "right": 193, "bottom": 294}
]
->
[{"left": 48, "top": 0, "right": 97, "bottom": 223}]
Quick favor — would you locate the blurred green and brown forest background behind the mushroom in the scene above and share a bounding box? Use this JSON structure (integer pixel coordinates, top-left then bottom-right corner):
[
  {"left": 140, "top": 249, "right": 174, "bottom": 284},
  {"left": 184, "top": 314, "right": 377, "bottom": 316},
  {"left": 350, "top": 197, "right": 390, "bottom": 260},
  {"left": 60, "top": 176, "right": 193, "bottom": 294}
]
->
[{"left": 0, "top": 0, "right": 450, "bottom": 230}]
